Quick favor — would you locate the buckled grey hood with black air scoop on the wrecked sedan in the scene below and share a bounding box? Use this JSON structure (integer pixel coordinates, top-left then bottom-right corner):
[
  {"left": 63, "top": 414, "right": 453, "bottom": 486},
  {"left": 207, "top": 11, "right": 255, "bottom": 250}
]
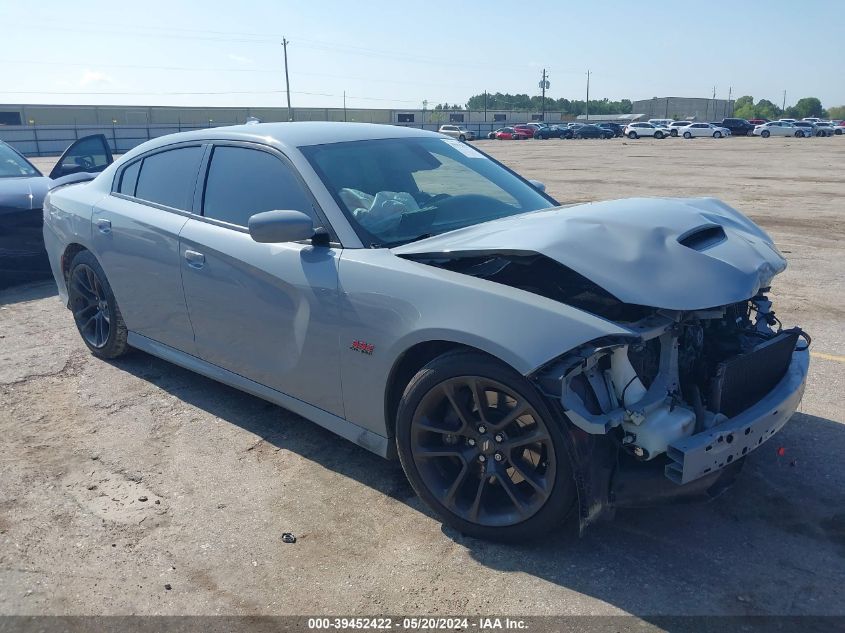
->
[{"left": 392, "top": 198, "right": 786, "bottom": 310}]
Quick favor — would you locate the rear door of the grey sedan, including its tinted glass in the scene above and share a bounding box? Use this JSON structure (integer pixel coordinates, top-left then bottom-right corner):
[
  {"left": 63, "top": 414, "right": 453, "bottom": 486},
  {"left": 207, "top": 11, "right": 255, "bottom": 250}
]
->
[{"left": 92, "top": 143, "right": 206, "bottom": 354}]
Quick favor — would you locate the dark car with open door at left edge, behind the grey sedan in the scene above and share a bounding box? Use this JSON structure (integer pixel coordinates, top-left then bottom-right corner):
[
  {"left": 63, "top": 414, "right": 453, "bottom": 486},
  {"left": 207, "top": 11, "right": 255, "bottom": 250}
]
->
[{"left": 0, "top": 134, "right": 112, "bottom": 288}]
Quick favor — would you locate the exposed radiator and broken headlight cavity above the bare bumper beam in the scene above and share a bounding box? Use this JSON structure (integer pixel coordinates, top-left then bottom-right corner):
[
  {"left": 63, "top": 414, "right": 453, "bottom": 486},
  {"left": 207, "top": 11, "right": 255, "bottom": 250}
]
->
[{"left": 534, "top": 294, "right": 809, "bottom": 470}]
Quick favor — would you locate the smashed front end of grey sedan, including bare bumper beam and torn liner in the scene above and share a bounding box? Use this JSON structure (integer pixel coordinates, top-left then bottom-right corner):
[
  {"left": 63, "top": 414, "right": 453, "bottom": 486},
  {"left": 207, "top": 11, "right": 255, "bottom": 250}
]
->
[{"left": 532, "top": 296, "right": 809, "bottom": 528}]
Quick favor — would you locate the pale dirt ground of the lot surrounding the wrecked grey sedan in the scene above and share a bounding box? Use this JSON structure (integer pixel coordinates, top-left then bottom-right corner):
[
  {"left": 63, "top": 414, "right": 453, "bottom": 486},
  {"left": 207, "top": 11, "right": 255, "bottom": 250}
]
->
[{"left": 0, "top": 137, "right": 845, "bottom": 617}]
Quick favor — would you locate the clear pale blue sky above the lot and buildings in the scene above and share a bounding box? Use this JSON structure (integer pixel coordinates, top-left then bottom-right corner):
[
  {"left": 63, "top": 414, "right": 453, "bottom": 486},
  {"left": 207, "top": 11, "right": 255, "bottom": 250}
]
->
[{"left": 0, "top": 0, "right": 845, "bottom": 108}]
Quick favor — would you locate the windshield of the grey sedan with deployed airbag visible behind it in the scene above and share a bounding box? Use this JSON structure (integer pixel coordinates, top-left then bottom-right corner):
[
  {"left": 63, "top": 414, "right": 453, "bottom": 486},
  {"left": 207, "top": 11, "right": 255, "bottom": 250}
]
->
[{"left": 300, "top": 137, "right": 555, "bottom": 247}]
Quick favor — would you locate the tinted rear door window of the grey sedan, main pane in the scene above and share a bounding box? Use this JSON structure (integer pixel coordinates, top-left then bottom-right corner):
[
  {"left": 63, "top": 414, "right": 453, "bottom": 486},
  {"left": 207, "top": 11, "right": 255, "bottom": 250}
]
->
[{"left": 137, "top": 147, "right": 203, "bottom": 211}]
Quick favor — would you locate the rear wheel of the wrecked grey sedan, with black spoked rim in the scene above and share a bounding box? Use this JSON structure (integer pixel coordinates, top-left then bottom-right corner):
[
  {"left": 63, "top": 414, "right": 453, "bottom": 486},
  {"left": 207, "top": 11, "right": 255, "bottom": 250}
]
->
[{"left": 68, "top": 251, "right": 129, "bottom": 358}]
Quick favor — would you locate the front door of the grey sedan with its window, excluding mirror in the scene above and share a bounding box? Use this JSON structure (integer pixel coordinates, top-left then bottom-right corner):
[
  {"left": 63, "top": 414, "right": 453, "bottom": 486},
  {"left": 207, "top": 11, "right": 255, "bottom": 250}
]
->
[{"left": 179, "top": 143, "right": 343, "bottom": 416}]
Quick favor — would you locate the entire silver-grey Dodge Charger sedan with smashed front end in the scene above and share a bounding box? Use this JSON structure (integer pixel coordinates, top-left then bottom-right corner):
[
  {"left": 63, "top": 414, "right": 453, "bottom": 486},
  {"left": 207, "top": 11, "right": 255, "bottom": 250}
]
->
[{"left": 44, "top": 123, "right": 809, "bottom": 540}]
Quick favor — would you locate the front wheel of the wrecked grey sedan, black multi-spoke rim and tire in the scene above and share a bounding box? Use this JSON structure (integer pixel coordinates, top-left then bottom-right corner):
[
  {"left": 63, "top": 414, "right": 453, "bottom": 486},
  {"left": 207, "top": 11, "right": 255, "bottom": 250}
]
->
[{"left": 396, "top": 351, "right": 576, "bottom": 541}]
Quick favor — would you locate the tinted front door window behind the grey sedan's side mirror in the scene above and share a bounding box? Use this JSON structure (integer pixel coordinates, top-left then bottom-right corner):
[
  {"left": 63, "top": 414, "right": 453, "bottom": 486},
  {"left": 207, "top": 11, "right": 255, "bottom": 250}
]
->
[{"left": 203, "top": 147, "right": 314, "bottom": 226}]
